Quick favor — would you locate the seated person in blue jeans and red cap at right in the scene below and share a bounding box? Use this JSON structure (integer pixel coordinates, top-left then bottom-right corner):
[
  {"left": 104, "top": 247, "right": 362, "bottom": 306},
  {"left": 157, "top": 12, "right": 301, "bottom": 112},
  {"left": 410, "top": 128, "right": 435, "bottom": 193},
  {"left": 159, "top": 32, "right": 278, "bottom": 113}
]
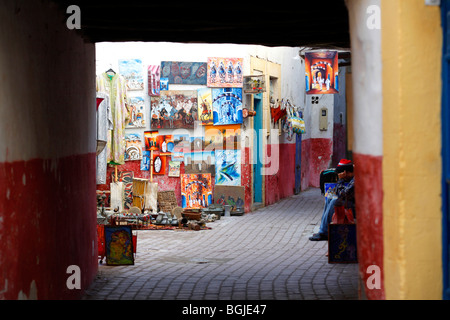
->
[{"left": 309, "top": 159, "right": 355, "bottom": 241}]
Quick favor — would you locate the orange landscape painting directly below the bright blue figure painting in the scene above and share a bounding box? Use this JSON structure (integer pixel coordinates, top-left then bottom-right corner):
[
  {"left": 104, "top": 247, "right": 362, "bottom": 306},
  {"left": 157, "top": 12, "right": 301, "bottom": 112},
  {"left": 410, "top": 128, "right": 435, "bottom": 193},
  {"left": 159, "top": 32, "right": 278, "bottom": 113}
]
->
[{"left": 205, "top": 124, "right": 241, "bottom": 150}]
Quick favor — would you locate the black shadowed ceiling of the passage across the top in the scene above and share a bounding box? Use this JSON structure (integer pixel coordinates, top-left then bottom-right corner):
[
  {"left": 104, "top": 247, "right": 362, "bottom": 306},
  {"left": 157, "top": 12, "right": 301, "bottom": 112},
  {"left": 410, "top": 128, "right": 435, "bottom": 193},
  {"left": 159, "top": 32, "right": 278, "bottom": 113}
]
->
[{"left": 54, "top": 0, "right": 350, "bottom": 49}]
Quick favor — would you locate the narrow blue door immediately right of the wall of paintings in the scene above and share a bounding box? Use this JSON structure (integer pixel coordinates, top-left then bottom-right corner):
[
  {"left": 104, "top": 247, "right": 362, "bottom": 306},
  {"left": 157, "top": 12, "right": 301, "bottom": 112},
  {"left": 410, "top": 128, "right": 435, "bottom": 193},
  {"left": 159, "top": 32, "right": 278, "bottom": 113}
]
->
[{"left": 253, "top": 93, "right": 264, "bottom": 203}]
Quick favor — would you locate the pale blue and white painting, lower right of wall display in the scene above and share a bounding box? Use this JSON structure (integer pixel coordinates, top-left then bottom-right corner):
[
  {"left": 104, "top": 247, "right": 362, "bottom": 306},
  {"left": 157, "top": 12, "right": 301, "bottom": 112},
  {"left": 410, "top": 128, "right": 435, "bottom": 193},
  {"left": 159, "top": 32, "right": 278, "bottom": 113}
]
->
[{"left": 215, "top": 150, "right": 241, "bottom": 186}]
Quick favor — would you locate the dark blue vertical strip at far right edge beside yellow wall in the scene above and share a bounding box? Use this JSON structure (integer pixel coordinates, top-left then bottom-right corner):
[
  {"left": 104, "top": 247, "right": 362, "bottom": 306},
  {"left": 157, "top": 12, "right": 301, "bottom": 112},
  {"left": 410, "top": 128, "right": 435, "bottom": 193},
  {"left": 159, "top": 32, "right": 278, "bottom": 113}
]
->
[{"left": 441, "top": 0, "right": 450, "bottom": 300}]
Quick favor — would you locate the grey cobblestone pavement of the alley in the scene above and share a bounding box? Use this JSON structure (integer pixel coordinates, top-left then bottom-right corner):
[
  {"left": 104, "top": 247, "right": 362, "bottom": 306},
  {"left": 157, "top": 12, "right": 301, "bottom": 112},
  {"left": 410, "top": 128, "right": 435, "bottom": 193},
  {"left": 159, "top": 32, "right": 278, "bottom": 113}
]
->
[{"left": 83, "top": 189, "right": 358, "bottom": 300}]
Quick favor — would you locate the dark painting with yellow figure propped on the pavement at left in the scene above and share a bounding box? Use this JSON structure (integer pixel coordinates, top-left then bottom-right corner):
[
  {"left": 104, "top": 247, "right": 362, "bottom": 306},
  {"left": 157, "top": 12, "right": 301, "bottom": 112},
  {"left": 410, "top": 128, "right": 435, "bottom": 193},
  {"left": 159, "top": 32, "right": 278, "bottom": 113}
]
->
[{"left": 105, "top": 225, "right": 134, "bottom": 266}]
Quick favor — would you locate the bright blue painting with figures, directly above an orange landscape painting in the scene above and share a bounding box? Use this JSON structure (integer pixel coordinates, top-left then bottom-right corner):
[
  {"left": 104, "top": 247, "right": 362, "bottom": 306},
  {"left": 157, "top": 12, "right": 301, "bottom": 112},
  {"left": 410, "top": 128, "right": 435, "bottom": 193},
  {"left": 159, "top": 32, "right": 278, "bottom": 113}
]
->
[{"left": 212, "top": 88, "right": 242, "bottom": 125}]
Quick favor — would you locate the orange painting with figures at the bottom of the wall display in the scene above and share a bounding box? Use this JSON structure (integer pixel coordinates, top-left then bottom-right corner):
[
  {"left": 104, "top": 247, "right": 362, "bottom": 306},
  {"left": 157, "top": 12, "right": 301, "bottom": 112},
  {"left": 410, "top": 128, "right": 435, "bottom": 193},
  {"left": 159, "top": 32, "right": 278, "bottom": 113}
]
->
[{"left": 181, "top": 173, "right": 212, "bottom": 209}]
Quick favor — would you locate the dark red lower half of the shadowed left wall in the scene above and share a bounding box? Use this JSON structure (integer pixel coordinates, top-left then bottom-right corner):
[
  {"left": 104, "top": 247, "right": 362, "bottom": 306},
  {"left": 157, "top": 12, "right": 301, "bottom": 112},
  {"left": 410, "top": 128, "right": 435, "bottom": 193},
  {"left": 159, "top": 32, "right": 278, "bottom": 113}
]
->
[{"left": 0, "top": 153, "right": 98, "bottom": 300}]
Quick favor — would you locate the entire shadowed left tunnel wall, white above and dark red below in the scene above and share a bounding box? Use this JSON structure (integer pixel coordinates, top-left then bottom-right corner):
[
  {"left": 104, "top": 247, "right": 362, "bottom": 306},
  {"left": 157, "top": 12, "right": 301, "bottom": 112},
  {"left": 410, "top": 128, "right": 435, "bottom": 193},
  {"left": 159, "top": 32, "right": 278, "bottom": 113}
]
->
[{"left": 0, "top": 1, "right": 98, "bottom": 300}]
